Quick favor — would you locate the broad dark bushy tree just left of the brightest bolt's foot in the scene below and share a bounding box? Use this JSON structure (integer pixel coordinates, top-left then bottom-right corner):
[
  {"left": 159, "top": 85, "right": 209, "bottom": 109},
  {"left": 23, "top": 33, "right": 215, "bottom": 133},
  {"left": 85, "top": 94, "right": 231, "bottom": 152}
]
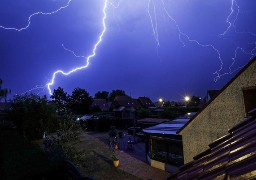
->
[{"left": 9, "top": 94, "right": 58, "bottom": 139}]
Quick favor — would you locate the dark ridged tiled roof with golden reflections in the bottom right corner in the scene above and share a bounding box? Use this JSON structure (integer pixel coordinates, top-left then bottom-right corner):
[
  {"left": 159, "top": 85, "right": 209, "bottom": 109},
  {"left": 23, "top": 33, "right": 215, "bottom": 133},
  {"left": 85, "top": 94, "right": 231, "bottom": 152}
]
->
[{"left": 169, "top": 110, "right": 256, "bottom": 179}]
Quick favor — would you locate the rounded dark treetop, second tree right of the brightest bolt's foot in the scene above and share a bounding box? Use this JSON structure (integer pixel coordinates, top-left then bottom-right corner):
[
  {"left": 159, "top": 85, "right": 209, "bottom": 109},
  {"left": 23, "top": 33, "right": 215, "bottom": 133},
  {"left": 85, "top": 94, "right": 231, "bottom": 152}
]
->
[{"left": 69, "top": 88, "right": 93, "bottom": 114}]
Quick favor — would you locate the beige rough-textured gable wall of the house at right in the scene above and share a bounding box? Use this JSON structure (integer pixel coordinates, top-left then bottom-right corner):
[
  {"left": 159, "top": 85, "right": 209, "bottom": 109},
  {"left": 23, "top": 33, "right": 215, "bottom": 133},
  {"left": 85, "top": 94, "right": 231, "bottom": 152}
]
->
[{"left": 177, "top": 58, "right": 256, "bottom": 163}]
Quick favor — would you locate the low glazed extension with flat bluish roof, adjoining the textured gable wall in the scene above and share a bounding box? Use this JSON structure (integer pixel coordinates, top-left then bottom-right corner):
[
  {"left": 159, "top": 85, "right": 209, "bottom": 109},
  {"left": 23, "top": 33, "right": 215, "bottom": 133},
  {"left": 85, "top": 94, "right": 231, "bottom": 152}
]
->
[{"left": 142, "top": 118, "right": 189, "bottom": 173}]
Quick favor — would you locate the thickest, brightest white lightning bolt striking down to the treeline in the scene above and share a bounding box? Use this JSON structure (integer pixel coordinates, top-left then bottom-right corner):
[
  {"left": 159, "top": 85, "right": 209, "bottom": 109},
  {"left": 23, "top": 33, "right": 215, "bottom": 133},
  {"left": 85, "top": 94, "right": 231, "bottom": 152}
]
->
[{"left": 46, "top": 0, "right": 108, "bottom": 95}]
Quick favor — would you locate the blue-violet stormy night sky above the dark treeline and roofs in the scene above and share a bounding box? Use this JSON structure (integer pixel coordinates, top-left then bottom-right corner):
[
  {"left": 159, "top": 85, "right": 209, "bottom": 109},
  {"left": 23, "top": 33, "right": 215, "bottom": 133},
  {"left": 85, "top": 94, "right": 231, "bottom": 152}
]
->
[{"left": 0, "top": 0, "right": 256, "bottom": 101}]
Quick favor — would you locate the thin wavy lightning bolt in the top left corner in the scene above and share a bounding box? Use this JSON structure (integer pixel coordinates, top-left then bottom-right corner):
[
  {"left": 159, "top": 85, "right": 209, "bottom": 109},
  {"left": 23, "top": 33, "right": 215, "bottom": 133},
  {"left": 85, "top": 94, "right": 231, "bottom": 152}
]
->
[{"left": 0, "top": 0, "right": 72, "bottom": 32}]
